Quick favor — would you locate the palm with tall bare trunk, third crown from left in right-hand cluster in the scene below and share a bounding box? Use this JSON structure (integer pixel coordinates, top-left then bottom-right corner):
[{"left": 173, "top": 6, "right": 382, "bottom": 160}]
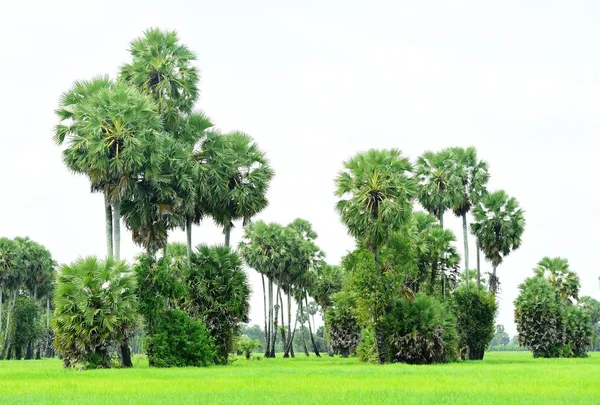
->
[{"left": 450, "top": 146, "right": 490, "bottom": 289}]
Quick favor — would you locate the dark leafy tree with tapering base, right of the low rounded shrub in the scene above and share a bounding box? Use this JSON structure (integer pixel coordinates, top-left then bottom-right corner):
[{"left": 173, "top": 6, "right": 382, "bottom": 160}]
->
[{"left": 187, "top": 245, "right": 251, "bottom": 364}]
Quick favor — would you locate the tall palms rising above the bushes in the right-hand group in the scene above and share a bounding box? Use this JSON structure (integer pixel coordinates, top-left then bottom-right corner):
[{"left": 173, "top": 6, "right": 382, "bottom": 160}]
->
[{"left": 335, "top": 147, "right": 525, "bottom": 362}]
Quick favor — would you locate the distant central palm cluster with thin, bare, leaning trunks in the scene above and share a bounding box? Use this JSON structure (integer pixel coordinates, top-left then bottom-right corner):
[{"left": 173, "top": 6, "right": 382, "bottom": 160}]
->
[{"left": 239, "top": 218, "right": 343, "bottom": 358}]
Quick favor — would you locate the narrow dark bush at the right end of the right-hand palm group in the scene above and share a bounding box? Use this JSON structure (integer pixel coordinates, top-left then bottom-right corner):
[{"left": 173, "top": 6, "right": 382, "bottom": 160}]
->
[{"left": 453, "top": 289, "right": 498, "bottom": 360}]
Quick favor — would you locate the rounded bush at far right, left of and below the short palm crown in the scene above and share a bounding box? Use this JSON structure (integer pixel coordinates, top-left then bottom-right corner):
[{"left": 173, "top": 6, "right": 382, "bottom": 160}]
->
[{"left": 515, "top": 277, "right": 565, "bottom": 357}]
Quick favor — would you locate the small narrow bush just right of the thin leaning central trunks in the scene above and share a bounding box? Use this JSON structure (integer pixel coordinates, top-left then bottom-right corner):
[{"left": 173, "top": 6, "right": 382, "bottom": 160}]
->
[{"left": 325, "top": 292, "right": 360, "bottom": 357}]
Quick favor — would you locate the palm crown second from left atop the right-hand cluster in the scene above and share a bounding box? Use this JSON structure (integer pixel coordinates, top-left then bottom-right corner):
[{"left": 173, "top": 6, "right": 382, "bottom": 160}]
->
[{"left": 416, "top": 149, "right": 463, "bottom": 228}]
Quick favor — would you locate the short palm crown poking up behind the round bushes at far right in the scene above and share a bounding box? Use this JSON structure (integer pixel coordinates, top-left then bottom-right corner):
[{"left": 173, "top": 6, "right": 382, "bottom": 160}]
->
[{"left": 534, "top": 256, "right": 581, "bottom": 303}]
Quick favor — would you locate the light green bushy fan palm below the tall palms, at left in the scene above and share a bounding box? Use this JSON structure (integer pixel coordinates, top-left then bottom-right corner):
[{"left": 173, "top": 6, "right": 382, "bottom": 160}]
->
[{"left": 52, "top": 257, "right": 136, "bottom": 368}]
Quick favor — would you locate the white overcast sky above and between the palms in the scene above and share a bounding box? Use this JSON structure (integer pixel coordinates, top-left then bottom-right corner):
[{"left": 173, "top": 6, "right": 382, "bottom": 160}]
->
[{"left": 0, "top": 0, "right": 600, "bottom": 334}]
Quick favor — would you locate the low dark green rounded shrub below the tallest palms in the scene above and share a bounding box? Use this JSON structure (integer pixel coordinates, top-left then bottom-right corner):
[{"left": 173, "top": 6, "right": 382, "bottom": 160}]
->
[{"left": 148, "top": 309, "right": 216, "bottom": 367}]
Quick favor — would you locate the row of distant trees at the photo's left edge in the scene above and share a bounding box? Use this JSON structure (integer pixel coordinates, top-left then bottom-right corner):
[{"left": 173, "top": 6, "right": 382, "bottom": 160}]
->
[{"left": 0, "top": 237, "right": 55, "bottom": 359}]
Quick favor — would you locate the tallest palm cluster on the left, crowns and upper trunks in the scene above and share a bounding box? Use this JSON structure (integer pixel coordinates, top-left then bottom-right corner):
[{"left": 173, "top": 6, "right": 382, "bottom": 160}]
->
[{"left": 54, "top": 29, "right": 274, "bottom": 259}]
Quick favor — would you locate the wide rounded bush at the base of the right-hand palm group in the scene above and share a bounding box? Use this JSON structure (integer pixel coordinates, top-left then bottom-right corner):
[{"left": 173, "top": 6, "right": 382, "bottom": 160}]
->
[{"left": 385, "top": 294, "right": 458, "bottom": 364}]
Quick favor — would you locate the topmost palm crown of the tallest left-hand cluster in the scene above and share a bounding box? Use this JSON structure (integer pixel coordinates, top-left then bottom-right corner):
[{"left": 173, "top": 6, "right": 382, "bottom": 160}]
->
[{"left": 120, "top": 28, "right": 199, "bottom": 129}]
